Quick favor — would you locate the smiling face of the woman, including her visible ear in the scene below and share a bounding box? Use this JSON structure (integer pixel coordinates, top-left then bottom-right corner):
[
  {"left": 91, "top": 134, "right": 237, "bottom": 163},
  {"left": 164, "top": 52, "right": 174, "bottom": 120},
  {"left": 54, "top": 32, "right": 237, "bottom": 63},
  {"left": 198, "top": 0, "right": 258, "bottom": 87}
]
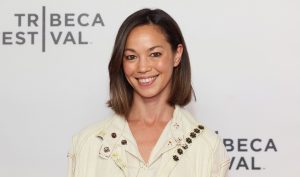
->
[{"left": 123, "top": 25, "right": 183, "bottom": 98}]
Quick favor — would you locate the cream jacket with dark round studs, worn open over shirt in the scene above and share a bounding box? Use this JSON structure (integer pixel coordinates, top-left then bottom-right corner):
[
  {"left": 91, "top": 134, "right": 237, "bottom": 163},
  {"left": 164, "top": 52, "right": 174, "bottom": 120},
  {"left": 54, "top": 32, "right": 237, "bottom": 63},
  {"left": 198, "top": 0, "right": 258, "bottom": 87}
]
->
[{"left": 68, "top": 106, "right": 230, "bottom": 177}]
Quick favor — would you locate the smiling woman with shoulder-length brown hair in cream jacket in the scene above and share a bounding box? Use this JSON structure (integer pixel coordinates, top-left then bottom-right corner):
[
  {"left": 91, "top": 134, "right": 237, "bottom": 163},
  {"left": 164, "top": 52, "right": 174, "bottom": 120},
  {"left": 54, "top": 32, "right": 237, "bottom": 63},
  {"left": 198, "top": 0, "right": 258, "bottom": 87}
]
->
[{"left": 68, "top": 9, "right": 229, "bottom": 177}]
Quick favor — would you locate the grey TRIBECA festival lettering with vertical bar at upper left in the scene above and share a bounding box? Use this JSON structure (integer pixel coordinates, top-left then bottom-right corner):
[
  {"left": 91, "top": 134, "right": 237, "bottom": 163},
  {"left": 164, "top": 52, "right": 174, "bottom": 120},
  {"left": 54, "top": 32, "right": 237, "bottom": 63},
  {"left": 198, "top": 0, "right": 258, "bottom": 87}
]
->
[{"left": 0, "top": 6, "right": 105, "bottom": 52}]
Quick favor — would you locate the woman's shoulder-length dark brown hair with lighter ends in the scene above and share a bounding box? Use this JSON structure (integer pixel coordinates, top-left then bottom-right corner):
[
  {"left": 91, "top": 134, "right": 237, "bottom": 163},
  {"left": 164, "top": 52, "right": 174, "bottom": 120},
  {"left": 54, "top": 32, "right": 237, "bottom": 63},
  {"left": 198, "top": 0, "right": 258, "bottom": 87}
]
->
[{"left": 107, "top": 9, "right": 196, "bottom": 116}]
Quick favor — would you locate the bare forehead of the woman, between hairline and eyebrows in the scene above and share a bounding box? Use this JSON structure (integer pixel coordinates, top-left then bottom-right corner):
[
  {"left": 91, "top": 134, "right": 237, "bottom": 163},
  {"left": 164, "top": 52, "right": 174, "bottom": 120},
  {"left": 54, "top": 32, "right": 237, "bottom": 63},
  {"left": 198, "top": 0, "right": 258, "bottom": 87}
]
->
[{"left": 125, "top": 25, "right": 169, "bottom": 48}]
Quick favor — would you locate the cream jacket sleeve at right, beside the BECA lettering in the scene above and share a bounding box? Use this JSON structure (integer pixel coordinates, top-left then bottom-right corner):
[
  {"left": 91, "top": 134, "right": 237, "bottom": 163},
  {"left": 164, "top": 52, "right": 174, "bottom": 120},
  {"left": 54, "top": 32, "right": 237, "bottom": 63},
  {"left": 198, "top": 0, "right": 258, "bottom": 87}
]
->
[{"left": 211, "top": 138, "right": 230, "bottom": 177}]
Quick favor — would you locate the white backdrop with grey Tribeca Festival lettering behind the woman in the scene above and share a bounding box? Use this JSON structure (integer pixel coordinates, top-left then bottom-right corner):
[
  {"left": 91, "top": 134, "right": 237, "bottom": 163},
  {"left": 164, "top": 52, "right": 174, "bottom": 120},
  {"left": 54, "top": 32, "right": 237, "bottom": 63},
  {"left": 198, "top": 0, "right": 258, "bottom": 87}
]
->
[{"left": 0, "top": 0, "right": 300, "bottom": 177}]
